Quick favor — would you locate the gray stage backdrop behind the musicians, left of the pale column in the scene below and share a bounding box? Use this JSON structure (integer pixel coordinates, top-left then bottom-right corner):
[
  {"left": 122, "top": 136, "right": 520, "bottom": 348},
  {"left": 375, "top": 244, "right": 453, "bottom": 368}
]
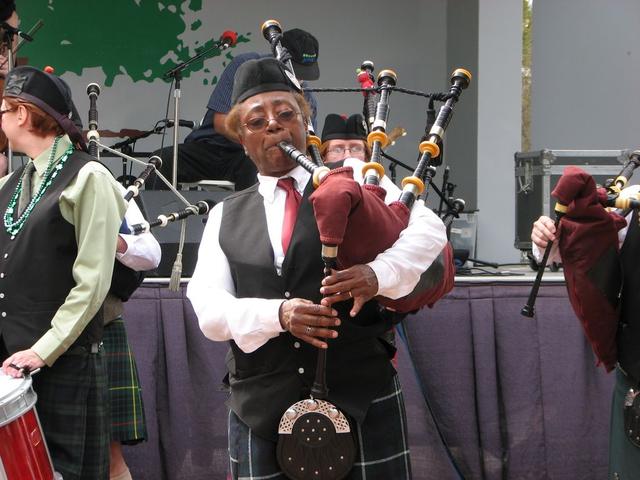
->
[{"left": 55, "top": 0, "right": 450, "bottom": 188}]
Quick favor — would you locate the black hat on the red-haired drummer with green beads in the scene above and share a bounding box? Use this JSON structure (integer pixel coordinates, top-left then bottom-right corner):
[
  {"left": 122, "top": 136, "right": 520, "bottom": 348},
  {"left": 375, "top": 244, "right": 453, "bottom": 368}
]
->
[{"left": 4, "top": 66, "right": 86, "bottom": 150}]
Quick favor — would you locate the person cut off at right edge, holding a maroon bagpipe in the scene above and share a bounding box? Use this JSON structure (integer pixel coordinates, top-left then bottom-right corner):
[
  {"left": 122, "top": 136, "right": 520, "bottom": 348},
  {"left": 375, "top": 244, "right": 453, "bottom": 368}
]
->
[{"left": 531, "top": 163, "right": 640, "bottom": 479}]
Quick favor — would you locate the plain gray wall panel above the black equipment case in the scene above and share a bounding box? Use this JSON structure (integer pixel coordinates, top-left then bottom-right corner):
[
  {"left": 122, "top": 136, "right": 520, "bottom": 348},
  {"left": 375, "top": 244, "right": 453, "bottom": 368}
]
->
[{"left": 531, "top": 0, "right": 640, "bottom": 150}]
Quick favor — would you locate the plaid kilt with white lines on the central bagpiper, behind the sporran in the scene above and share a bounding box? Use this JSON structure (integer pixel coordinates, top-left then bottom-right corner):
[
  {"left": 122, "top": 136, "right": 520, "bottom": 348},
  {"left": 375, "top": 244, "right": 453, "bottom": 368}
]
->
[{"left": 229, "top": 375, "right": 411, "bottom": 480}]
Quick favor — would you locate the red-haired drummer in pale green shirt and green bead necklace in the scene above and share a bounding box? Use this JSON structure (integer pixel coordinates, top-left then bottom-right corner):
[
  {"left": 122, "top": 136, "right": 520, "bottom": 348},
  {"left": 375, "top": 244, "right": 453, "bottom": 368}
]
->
[{"left": 0, "top": 67, "right": 127, "bottom": 480}]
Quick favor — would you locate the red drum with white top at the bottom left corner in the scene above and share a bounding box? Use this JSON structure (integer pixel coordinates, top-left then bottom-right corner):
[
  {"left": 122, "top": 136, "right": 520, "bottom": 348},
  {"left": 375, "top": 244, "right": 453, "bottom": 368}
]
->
[{"left": 0, "top": 372, "right": 60, "bottom": 480}]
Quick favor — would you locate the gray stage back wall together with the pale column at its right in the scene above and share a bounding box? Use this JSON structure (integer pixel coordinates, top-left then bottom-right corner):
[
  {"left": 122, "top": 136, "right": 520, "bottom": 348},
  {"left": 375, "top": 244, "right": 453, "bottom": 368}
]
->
[{"left": 20, "top": 0, "right": 521, "bottom": 262}]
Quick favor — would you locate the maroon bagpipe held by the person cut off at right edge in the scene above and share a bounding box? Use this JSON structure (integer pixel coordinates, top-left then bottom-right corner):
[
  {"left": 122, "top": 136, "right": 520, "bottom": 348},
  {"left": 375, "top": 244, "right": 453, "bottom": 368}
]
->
[{"left": 521, "top": 150, "right": 640, "bottom": 371}]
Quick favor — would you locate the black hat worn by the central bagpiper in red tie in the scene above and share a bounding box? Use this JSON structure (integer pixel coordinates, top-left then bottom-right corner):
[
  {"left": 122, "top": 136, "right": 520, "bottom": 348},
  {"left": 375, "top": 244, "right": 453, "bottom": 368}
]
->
[{"left": 231, "top": 57, "right": 302, "bottom": 105}]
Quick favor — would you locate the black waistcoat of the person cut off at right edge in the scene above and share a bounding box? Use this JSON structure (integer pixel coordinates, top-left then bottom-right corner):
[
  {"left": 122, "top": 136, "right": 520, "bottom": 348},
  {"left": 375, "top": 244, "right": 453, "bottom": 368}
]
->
[{"left": 618, "top": 212, "right": 640, "bottom": 382}]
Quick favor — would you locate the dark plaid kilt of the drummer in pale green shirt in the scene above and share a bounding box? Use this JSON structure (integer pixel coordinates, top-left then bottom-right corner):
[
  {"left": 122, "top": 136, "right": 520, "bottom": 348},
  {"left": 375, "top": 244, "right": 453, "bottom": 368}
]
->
[{"left": 33, "top": 350, "right": 109, "bottom": 480}]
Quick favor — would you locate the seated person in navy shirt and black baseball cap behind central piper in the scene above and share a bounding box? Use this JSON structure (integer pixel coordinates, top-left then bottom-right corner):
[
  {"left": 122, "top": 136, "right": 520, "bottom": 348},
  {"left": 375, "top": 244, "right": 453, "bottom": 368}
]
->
[{"left": 150, "top": 28, "right": 320, "bottom": 190}]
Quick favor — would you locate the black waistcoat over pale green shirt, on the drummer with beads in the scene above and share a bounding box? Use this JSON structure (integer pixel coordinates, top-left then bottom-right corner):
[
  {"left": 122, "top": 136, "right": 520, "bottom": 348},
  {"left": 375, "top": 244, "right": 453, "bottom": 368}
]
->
[{"left": 0, "top": 152, "right": 102, "bottom": 354}]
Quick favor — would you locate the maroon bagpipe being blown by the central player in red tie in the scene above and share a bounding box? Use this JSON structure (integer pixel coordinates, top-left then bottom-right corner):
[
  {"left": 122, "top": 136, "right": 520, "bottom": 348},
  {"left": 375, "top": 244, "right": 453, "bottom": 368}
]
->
[{"left": 279, "top": 64, "right": 471, "bottom": 313}]
